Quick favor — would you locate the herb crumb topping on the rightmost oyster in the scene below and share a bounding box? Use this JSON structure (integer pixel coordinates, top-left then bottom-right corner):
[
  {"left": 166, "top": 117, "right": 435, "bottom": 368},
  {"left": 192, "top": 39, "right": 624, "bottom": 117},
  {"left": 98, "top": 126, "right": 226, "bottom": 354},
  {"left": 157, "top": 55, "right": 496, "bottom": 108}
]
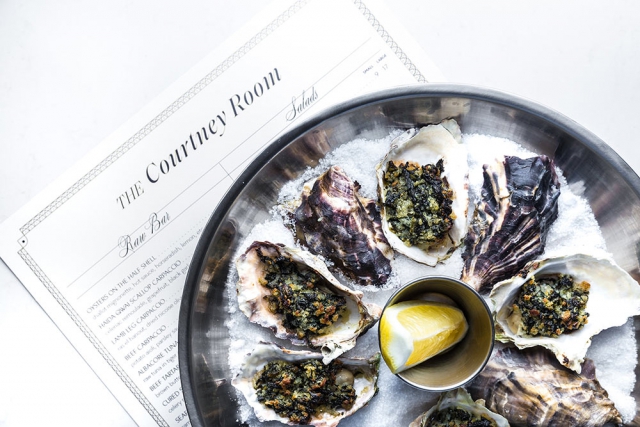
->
[{"left": 510, "top": 274, "right": 590, "bottom": 337}]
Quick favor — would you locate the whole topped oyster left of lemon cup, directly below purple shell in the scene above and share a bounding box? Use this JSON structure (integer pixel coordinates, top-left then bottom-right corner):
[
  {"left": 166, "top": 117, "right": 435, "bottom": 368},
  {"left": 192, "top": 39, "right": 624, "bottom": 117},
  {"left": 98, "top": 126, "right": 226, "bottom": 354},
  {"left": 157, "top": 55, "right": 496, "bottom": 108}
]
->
[{"left": 236, "top": 242, "right": 382, "bottom": 363}]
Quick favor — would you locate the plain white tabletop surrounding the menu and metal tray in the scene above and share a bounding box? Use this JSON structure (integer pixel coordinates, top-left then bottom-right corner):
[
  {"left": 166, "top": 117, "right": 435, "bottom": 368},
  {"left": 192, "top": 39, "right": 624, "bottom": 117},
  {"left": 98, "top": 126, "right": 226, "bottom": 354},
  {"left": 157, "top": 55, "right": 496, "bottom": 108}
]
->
[{"left": 0, "top": 0, "right": 640, "bottom": 427}]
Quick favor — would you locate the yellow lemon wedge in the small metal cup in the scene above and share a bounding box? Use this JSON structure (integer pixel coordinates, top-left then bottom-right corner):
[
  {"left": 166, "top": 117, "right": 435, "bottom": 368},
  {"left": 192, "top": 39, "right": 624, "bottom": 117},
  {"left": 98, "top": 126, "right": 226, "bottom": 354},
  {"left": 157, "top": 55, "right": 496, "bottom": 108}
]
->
[{"left": 380, "top": 301, "right": 469, "bottom": 374}]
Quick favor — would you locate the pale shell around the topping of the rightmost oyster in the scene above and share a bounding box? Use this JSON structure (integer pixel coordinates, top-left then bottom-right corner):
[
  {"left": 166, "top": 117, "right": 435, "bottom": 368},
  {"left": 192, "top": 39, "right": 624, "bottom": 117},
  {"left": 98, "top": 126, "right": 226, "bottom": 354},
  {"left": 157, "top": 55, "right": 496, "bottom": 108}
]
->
[{"left": 490, "top": 254, "right": 640, "bottom": 372}]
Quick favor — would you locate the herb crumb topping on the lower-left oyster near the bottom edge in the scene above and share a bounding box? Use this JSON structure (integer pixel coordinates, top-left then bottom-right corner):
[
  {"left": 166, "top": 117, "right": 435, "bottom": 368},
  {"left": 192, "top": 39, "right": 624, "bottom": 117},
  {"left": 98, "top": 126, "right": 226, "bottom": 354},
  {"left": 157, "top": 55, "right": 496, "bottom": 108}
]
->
[{"left": 254, "top": 359, "right": 356, "bottom": 424}]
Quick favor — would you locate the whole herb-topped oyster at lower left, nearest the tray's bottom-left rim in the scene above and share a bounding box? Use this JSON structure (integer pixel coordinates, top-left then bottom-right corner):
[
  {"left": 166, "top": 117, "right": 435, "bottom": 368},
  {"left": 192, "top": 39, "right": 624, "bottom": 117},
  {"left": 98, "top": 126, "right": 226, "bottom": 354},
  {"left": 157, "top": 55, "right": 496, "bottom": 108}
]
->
[{"left": 232, "top": 343, "right": 380, "bottom": 427}]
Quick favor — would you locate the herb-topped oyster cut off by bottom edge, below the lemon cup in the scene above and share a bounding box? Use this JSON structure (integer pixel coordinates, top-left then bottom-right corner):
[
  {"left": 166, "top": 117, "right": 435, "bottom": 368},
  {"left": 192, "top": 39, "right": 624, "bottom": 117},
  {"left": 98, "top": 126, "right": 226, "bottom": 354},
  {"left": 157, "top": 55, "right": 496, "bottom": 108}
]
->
[{"left": 409, "top": 388, "right": 509, "bottom": 427}]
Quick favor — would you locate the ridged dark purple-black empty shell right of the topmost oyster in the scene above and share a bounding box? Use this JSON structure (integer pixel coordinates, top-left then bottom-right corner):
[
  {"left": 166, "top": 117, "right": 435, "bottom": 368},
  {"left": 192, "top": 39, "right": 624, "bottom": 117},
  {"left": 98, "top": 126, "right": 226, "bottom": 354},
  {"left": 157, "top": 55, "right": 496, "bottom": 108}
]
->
[{"left": 461, "top": 156, "right": 560, "bottom": 292}]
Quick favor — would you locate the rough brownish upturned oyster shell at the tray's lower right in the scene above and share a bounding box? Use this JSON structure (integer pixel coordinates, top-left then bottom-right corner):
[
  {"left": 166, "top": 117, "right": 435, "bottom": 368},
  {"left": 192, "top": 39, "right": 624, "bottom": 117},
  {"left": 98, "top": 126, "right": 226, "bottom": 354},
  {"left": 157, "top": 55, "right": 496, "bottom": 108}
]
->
[{"left": 467, "top": 347, "right": 622, "bottom": 427}]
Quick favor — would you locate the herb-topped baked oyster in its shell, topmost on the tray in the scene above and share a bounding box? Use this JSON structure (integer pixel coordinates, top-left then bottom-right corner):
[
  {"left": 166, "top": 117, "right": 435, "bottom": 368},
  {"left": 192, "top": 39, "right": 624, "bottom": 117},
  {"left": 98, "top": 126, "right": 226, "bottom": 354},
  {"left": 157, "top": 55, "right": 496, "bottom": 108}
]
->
[{"left": 376, "top": 119, "right": 469, "bottom": 266}]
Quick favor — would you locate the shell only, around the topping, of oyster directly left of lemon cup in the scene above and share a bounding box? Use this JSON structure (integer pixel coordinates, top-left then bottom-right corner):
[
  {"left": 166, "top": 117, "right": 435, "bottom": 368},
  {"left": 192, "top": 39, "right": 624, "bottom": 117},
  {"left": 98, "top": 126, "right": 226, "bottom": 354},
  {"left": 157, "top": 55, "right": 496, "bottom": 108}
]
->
[{"left": 236, "top": 242, "right": 382, "bottom": 363}]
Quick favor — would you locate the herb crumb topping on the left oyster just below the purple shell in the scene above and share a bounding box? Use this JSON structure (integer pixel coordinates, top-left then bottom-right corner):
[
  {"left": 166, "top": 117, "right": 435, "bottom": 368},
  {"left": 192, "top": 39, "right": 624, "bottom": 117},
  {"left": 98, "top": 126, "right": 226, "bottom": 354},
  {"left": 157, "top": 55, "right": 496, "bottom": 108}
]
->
[{"left": 258, "top": 252, "right": 347, "bottom": 339}]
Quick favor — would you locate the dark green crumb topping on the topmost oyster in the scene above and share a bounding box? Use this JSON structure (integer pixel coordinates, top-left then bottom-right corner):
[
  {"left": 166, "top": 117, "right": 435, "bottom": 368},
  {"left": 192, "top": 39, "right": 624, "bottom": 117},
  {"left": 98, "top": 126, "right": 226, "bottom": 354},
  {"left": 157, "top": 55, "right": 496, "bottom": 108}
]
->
[{"left": 384, "top": 159, "right": 455, "bottom": 247}]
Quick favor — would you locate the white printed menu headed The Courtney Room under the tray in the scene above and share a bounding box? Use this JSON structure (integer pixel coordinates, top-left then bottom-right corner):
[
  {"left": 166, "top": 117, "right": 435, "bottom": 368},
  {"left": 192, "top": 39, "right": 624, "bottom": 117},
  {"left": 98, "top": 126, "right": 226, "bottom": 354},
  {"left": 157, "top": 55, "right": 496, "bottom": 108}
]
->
[{"left": 0, "top": 0, "right": 441, "bottom": 426}]
